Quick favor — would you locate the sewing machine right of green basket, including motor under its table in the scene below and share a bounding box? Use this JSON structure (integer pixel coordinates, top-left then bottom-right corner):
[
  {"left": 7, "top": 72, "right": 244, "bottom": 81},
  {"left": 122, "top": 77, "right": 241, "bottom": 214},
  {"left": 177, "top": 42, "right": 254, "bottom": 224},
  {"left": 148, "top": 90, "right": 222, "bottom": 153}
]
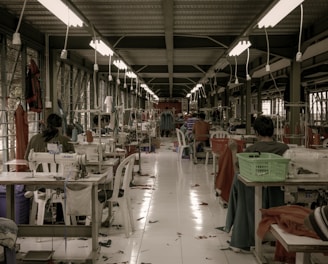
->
[{"left": 284, "top": 147, "right": 328, "bottom": 207}]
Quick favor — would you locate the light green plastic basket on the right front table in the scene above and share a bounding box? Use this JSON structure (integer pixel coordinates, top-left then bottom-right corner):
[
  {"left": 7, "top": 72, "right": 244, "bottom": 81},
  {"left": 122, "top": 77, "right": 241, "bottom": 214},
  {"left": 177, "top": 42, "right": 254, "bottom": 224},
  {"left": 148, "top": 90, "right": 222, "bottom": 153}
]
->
[{"left": 237, "top": 152, "right": 290, "bottom": 182}]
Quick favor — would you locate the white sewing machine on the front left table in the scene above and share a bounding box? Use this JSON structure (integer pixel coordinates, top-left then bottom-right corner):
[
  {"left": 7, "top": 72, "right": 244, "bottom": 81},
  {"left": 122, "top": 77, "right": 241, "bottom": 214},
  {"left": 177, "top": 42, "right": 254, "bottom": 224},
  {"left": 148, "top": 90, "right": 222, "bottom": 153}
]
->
[{"left": 28, "top": 149, "right": 86, "bottom": 179}]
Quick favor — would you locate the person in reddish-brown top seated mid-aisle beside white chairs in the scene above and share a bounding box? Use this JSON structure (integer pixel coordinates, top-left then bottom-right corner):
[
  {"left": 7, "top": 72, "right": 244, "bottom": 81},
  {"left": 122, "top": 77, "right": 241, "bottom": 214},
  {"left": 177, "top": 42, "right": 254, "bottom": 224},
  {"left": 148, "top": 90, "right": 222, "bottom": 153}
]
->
[{"left": 192, "top": 112, "right": 211, "bottom": 158}]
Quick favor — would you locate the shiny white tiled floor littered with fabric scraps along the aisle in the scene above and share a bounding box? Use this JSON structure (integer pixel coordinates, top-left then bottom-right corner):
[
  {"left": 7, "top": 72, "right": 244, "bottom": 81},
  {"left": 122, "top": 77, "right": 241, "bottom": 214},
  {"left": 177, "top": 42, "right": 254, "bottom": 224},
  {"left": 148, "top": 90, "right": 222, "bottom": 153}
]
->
[{"left": 18, "top": 138, "right": 257, "bottom": 264}]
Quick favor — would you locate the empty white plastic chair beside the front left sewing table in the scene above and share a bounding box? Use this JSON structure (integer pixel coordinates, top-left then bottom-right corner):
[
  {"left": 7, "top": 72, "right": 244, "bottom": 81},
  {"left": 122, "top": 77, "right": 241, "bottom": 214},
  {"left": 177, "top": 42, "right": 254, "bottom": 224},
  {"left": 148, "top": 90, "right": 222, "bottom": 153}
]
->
[{"left": 99, "top": 153, "right": 137, "bottom": 237}]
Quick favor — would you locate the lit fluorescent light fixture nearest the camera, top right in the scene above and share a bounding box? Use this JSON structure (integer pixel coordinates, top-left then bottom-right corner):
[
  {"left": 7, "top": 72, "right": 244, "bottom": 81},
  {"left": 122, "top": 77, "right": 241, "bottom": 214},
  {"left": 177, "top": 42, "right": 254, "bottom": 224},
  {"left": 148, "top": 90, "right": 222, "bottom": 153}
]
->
[{"left": 258, "top": 0, "right": 304, "bottom": 28}]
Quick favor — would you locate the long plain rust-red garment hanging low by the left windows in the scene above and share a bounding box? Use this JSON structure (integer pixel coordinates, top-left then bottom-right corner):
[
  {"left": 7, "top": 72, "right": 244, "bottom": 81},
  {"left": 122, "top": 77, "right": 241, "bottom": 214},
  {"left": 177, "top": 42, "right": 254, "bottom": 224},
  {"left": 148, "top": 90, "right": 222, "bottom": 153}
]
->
[{"left": 15, "top": 104, "right": 28, "bottom": 171}]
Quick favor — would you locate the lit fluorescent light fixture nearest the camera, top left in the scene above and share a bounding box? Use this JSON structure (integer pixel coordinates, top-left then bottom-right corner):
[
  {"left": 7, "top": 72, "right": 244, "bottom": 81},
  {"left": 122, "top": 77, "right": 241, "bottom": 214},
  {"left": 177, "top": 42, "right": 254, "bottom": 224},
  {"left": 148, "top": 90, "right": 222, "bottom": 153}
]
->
[{"left": 38, "top": 0, "right": 83, "bottom": 27}]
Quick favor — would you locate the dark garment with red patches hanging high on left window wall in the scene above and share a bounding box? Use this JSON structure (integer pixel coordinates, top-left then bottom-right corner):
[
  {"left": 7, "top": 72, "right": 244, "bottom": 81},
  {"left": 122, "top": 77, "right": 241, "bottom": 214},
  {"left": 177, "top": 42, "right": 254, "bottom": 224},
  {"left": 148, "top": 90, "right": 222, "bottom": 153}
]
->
[{"left": 25, "top": 59, "right": 42, "bottom": 113}]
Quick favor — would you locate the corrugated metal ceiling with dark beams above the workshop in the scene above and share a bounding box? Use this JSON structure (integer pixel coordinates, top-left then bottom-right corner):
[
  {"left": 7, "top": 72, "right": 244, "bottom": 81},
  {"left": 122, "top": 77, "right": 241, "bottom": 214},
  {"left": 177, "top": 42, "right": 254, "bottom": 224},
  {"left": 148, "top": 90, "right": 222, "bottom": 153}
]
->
[{"left": 0, "top": 0, "right": 328, "bottom": 98}]
